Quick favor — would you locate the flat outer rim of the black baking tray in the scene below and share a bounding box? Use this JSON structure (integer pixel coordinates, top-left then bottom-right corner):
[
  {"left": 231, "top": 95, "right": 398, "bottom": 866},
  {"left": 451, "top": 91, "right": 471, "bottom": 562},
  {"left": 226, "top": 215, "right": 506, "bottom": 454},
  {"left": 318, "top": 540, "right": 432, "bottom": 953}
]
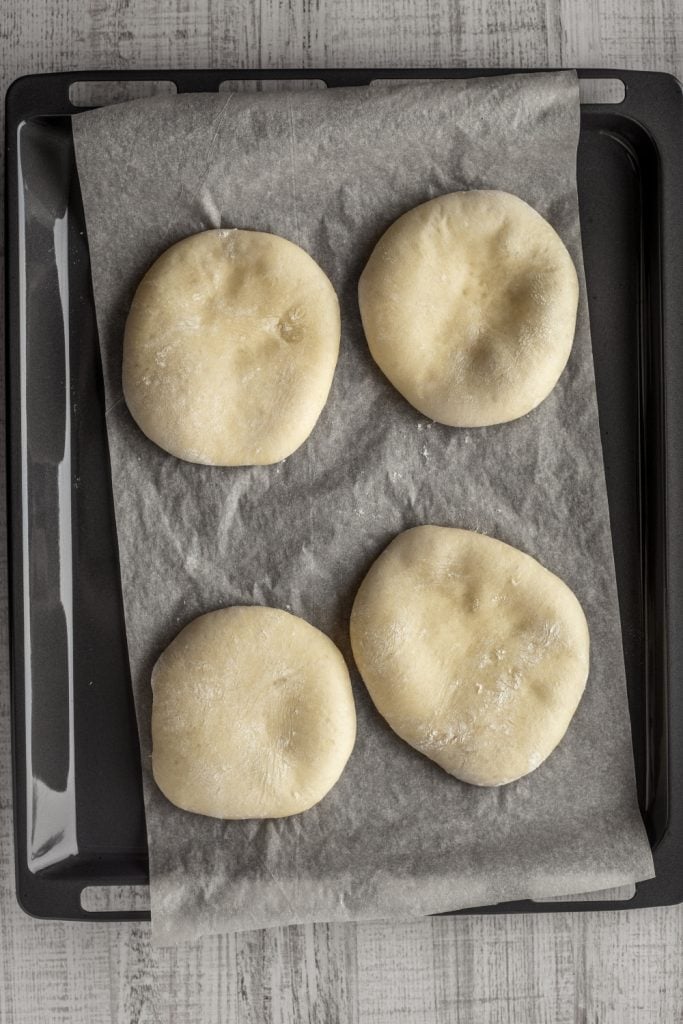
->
[{"left": 5, "top": 66, "right": 683, "bottom": 921}]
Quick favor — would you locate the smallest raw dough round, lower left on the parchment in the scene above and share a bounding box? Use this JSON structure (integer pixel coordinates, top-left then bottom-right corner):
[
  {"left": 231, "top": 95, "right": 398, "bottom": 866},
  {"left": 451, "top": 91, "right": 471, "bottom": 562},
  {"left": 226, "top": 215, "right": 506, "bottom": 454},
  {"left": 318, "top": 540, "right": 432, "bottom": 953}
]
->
[{"left": 152, "top": 606, "right": 355, "bottom": 818}]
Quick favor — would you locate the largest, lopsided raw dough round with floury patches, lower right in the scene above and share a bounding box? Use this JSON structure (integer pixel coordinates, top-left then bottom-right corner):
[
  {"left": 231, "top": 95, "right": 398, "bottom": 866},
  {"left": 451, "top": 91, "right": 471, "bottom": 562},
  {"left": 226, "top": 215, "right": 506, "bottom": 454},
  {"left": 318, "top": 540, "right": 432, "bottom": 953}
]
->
[{"left": 351, "top": 526, "right": 589, "bottom": 785}]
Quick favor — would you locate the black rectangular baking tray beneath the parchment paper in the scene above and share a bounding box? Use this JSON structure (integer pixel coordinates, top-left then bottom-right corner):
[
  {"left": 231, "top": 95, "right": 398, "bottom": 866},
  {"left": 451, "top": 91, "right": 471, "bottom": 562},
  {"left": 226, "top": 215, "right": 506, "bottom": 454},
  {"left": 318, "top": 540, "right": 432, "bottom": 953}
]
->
[{"left": 5, "top": 68, "right": 683, "bottom": 920}]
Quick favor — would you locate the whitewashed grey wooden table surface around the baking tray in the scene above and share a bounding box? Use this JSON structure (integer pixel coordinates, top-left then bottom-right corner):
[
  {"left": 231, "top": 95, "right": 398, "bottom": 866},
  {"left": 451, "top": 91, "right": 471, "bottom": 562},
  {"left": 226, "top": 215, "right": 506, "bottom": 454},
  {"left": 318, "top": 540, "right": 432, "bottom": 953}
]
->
[{"left": 0, "top": 0, "right": 683, "bottom": 1024}]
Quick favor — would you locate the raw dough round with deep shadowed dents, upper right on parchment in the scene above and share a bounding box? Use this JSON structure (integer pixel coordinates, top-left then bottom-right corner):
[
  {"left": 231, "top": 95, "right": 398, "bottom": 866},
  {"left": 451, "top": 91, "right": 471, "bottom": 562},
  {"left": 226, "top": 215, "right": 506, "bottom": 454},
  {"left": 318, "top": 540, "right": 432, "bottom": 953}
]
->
[{"left": 358, "top": 191, "right": 579, "bottom": 427}]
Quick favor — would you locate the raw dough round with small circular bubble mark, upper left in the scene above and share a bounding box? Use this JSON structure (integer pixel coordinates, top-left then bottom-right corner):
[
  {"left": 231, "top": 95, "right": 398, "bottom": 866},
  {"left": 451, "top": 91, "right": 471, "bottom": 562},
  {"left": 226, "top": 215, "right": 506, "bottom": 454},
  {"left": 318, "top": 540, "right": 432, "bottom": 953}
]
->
[{"left": 123, "top": 229, "right": 340, "bottom": 466}]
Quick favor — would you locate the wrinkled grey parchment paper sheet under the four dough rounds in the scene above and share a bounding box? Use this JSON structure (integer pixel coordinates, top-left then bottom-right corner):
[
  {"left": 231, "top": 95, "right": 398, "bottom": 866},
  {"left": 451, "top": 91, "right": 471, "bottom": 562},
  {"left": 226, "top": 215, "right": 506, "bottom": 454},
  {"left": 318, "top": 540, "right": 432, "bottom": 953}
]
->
[{"left": 74, "top": 73, "right": 653, "bottom": 944}]
